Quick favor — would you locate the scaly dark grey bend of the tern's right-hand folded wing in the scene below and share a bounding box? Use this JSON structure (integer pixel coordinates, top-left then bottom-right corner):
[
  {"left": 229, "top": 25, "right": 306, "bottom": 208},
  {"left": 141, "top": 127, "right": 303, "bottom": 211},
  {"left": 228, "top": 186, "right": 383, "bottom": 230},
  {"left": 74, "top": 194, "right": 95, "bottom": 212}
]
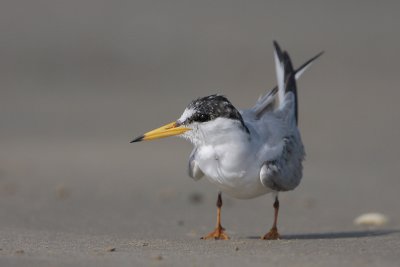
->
[{"left": 260, "top": 135, "right": 305, "bottom": 191}]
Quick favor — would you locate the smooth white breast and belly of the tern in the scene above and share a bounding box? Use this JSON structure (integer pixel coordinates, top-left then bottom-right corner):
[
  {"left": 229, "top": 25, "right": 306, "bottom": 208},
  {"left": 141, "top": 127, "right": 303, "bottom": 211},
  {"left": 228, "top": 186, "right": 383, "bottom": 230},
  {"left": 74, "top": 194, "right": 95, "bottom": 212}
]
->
[{"left": 184, "top": 118, "right": 271, "bottom": 198}]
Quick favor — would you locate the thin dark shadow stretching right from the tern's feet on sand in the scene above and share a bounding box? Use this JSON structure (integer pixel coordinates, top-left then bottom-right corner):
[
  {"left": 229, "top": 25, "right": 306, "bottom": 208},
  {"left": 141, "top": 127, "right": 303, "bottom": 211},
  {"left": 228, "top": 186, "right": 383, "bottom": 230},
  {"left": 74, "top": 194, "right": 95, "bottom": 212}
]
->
[{"left": 247, "top": 230, "right": 400, "bottom": 240}]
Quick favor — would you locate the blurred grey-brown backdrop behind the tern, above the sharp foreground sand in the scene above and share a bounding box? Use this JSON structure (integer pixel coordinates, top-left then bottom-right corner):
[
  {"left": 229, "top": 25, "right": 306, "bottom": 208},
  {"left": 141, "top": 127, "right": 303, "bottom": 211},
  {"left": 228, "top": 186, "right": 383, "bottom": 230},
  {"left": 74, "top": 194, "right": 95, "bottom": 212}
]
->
[{"left": 0, "top": 0, "right": 400, "bottom": 238}]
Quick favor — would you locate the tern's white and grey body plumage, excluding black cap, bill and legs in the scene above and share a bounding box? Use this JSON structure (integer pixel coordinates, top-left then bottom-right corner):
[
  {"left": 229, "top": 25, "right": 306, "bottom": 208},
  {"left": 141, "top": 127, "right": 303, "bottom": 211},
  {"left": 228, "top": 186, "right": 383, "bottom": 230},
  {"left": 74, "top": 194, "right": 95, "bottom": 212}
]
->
[{"left": 183, "top": 43, "right": 319, "bottom": 198}]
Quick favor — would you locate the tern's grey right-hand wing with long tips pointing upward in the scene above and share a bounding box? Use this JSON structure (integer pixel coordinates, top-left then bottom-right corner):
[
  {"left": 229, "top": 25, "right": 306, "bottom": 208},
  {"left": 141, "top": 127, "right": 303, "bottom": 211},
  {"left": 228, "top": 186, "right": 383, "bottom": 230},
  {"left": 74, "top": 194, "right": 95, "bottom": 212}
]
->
[{"left": 260, "top": 42, "right": 322, "bottom": 191}]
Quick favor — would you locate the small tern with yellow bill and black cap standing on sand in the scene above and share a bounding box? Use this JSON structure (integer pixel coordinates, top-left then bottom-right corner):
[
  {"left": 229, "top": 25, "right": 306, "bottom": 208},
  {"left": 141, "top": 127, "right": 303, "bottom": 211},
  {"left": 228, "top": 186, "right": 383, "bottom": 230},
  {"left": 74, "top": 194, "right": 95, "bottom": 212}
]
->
[{"left": 131, "top": 41, "right": 323, "bottom": 240}]
